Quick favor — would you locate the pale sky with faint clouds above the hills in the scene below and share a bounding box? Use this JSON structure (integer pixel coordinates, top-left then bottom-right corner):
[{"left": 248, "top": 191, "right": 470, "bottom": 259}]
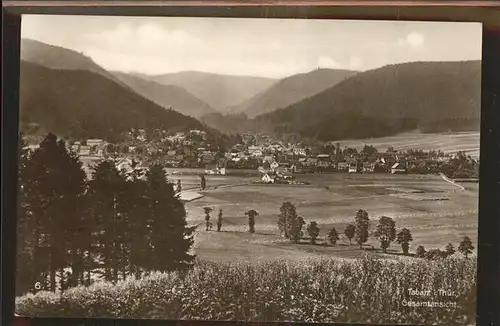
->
[{"left": 21, "top": 15, "right": 482, "bottom": 78}]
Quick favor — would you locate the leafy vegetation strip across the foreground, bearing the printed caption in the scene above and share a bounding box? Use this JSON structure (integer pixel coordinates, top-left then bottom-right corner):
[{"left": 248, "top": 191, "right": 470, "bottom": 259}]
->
[{"left": 16, "top": 257, "right": 476, "bottom": 325}]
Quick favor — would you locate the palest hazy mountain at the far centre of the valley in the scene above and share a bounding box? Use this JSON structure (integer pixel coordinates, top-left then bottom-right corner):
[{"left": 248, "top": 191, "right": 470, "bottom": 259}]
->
[{"left": 139, "top": 71, "right": 275, "bottom": 113}]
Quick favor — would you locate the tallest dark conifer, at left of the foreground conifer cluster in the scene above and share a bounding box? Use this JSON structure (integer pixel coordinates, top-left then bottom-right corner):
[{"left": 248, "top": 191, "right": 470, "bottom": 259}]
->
[{"left": 21, "top": 133, "right": 86, "bottom": 291}]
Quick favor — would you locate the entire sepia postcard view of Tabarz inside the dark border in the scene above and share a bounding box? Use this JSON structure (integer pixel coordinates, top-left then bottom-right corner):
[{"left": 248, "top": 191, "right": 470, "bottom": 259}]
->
[{"left": 16, "top": 15, "right": 482, "bottom": 325}]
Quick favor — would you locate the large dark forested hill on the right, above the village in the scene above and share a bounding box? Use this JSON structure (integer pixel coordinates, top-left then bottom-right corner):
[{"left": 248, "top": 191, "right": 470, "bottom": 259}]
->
[{"left": 254, "top": 61, "right": 481, "bottom": 140}]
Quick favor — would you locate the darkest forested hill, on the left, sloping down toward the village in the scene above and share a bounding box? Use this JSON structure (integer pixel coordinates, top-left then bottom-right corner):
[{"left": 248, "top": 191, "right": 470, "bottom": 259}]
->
[{"left": 20, "top": 61, "right": 207, "bottom": 141}]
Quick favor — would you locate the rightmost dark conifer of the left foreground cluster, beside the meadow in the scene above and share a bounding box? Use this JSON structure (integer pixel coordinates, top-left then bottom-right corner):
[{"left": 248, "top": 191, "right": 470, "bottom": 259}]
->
[{"left": 146, "top": 164, "right": 195, "bottom": 271}]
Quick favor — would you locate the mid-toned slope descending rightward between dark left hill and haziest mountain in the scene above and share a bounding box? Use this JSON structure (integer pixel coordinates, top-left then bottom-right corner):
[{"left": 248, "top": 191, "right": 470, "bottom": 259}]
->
[{"left": 113, "top": 72, "right": 217, "bottom": 118}]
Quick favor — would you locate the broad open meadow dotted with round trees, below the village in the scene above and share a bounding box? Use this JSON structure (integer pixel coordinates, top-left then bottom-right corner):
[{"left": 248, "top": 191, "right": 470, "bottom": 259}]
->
[{"left": 183, "top": 173, "right": 478, "bottom": 261}]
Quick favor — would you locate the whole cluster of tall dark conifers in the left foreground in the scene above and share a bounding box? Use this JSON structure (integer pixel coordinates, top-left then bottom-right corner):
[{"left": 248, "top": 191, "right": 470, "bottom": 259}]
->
[{"left": 16, "top": 133, "right": 195, "bottom": 295}]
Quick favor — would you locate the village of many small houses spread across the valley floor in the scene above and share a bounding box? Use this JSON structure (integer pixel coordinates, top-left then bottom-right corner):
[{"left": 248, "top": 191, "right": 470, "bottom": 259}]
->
[{"left": 24, "top": 129, "right": 477, "bottom": 183}]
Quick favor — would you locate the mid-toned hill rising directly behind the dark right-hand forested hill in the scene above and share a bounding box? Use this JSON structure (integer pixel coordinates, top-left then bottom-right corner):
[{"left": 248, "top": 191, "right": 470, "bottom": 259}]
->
[{"left": 234, "top": 69, "right": 356, "bottom": 118}]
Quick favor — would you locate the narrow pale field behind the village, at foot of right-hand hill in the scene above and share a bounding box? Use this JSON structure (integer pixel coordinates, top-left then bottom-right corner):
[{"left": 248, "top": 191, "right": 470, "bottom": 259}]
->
[{"left": 339, "top": 132, "right": 479, "bottom": 158}]
